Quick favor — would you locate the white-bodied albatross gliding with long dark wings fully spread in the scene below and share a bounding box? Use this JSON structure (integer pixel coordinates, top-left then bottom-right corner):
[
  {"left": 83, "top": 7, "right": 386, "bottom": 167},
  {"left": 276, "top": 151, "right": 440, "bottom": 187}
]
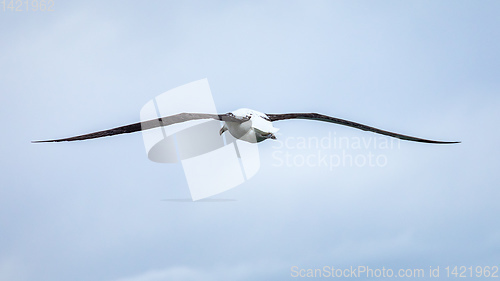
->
[{"left": 32, "top": 108, "right": 460, "bottom": 144}]
